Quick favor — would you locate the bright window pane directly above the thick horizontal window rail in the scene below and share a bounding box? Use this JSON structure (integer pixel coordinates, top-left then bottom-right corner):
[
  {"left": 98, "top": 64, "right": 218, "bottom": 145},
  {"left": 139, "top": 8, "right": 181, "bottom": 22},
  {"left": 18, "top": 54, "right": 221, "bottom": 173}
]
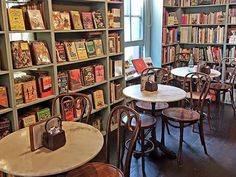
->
[{"left": 131, "top": 17, "right": 143, "bottom": 41}]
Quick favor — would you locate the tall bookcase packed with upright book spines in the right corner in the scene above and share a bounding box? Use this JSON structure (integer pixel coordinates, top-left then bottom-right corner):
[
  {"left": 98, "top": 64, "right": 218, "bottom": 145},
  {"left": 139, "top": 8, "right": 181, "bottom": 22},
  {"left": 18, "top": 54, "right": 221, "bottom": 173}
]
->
[{"left": 162, "top": 0, "right": 236, "bottom": 66}]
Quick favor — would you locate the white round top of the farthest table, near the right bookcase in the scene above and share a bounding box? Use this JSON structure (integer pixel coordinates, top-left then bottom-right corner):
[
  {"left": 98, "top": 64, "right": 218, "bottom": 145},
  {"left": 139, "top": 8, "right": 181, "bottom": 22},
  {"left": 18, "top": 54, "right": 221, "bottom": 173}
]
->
[{"left": 171, "top": 67, "right": 221, "bottom": 78}]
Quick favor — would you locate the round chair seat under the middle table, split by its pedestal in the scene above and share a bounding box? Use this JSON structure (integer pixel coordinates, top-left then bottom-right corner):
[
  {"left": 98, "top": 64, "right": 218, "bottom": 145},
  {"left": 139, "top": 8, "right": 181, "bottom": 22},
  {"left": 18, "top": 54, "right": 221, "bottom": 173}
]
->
[{"left": 135, "top": 101, "right": 169, "bottom": 111}]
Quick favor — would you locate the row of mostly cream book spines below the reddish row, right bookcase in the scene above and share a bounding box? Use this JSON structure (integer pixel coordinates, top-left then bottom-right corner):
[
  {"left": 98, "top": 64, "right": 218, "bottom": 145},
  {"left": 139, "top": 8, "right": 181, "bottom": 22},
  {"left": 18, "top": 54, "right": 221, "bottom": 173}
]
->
[{"left": 180, "top": 26, "right": 225, "bottom": 44}]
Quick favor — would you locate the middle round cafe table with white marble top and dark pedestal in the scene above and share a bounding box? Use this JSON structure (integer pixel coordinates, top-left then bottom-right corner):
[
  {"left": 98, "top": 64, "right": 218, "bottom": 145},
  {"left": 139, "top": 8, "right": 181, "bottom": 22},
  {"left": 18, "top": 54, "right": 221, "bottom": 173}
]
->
[{"left": 123, "top": 84, "right": 186, "bottom": 158}]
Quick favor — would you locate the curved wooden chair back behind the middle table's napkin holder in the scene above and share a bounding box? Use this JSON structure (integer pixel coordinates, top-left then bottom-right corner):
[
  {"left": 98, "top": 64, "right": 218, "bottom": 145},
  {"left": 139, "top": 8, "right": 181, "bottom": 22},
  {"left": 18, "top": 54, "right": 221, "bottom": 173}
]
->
[{"left": 141, "top": 67, "right": 170, "bottom": 84}]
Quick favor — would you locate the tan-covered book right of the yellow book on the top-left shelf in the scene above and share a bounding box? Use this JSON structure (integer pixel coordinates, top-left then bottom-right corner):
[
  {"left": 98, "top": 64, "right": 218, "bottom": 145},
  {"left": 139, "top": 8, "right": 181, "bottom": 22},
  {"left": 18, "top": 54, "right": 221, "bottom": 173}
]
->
[{"left": 27, "top": 9, "right": 45, "bottom": 30}]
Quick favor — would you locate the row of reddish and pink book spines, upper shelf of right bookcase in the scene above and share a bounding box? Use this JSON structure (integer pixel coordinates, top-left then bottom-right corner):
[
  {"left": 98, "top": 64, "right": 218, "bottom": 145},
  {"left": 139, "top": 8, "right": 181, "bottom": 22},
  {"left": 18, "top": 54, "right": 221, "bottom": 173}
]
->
[{"left": 181, "top": 11, "right": 225, "bottom": 25}]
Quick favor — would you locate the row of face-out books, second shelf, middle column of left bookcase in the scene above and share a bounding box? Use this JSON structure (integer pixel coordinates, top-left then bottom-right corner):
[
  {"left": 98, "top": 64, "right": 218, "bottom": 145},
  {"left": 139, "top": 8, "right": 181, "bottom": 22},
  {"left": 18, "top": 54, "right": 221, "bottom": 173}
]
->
[{"left": 55, "top": 38, "right": 104, "bottom": 63}]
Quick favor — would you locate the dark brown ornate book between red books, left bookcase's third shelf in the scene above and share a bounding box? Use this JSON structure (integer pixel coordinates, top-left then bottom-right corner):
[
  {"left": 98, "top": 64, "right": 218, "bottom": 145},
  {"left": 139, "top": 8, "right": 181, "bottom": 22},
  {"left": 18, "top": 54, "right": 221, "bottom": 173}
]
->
[{"left": 81, "top": 66, "right": 95, "bottom": 86}]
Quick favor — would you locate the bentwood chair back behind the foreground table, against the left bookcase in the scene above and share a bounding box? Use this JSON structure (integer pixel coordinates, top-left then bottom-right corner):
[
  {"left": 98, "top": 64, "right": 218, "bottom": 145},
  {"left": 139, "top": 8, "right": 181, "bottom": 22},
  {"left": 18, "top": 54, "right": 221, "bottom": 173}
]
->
[{"left": 52, "top": 93, "right": 92, "bottom": 123}]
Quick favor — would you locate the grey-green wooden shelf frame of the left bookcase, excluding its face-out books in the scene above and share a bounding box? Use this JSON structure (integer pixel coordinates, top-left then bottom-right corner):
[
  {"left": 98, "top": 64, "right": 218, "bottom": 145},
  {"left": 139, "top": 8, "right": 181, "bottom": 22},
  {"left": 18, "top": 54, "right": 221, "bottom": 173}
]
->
[{"left": 0, "top": 0, "right": 125, "bottom": 134}]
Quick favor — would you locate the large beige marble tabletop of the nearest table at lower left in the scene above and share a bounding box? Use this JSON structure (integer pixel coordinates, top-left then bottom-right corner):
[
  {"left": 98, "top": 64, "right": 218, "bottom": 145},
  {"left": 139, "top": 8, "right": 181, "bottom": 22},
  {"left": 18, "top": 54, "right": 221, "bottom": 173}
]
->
[{"left": 0, "top": 122, "right": 104, "bottom": 176}]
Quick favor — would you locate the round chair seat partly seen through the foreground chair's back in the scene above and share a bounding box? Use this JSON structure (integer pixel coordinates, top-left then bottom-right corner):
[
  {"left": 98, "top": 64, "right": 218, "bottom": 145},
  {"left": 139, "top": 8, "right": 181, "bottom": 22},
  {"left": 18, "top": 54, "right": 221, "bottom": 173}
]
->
[{"left": 122, "top": 114, "right": 157, "bottom": 129}]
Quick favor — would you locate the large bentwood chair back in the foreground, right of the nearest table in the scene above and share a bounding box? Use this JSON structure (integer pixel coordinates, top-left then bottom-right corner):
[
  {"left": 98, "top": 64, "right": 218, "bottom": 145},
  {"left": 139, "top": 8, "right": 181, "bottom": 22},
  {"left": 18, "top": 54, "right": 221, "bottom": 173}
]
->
[{"left": 105, "top": 105, "right": 141, "bottom": 177}]
